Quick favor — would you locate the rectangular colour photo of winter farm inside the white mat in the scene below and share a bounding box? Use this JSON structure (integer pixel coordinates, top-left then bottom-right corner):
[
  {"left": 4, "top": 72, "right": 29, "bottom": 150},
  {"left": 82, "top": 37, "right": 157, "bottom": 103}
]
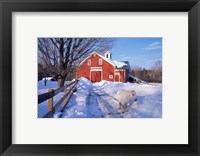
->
[{"left": 38, "top": 37, "right": 162, "bottom": 118}]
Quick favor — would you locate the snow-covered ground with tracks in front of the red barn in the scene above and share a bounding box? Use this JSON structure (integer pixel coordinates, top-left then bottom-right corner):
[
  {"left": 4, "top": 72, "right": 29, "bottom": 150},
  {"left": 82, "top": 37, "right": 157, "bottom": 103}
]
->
[{"left": 38, "top": 78, "right": 162, "bottom": 118}]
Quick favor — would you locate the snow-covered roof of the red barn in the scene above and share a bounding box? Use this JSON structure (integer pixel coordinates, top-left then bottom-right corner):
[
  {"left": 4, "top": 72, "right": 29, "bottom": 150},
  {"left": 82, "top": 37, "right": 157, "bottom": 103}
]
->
[{"left": 80, "top": 51, "right": 129, "bottom": 69}]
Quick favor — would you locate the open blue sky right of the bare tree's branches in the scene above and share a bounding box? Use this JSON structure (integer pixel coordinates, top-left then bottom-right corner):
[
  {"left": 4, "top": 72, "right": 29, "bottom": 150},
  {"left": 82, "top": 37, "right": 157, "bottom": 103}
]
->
[{"left": 110, "top": 38, "right": 162, "bottom": 69}]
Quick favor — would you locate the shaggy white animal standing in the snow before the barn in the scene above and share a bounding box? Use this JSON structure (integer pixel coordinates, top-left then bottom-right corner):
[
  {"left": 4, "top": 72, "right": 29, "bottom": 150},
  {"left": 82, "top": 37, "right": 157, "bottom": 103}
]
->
[{"left": 116, "top": 89, "right": 137, "bottom": 111}]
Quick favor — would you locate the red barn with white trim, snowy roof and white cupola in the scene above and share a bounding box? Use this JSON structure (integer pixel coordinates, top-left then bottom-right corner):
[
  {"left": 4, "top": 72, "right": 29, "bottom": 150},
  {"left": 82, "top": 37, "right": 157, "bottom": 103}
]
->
[{"left": 77, "top": 51, "right": 130, "bottom": 82}]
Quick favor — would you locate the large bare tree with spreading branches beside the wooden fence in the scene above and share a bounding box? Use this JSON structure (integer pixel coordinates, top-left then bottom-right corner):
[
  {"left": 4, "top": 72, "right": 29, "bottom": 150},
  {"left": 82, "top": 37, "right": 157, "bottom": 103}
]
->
[{"left": 38, "top": 38, "right": 113, "bottom": 87}]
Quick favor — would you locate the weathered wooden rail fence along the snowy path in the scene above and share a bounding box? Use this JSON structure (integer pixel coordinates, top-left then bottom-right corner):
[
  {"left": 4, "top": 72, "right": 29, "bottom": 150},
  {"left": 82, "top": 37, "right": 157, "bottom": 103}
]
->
[{"left": 38, "top": 80, "right": 78, "bottom": 118}]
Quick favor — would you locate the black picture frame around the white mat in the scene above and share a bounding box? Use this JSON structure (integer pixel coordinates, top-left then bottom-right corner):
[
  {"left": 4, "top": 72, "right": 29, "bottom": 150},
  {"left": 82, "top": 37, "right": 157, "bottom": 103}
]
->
[{"left": 0, "top": 0, "right": 200, "bottom": 156}]
